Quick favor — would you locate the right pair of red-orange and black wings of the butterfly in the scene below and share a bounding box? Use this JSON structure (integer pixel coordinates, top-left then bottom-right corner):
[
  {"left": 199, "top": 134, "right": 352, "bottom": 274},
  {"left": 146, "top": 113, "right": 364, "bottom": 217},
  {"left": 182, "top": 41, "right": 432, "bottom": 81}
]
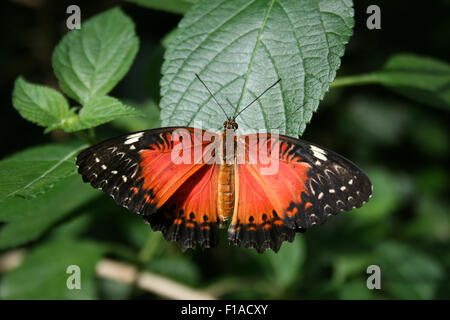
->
[{"left": 229, "top": 134, "right": 372, "bottom": 252}]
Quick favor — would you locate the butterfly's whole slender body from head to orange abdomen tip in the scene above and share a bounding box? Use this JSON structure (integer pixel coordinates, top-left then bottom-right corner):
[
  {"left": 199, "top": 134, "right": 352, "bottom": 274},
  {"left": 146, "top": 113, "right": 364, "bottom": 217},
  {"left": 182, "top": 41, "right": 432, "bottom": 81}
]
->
[{"left": 217, "top": 119, "right": 238, "bottom": 225}]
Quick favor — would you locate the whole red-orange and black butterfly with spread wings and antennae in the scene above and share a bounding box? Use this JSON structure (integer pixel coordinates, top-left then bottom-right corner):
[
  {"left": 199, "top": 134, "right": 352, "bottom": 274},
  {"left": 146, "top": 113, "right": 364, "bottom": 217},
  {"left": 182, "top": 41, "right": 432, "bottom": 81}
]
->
[{"left": 76, "top": 76, "right": 372, "bottom": 253}]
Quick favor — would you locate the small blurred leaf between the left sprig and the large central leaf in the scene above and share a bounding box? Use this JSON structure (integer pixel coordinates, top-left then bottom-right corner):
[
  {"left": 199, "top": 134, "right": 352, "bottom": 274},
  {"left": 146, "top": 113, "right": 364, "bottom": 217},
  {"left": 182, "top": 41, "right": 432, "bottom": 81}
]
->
[{"left": 111, "top": 100, "right": 161, "bottom": 132}]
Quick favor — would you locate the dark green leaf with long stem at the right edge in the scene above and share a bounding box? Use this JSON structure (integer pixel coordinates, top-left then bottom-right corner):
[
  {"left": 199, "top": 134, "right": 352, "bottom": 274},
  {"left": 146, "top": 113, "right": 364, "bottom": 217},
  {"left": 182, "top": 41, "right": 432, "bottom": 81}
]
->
[{"left": 333, "top": 54, "right": 450, "bottom": 110}]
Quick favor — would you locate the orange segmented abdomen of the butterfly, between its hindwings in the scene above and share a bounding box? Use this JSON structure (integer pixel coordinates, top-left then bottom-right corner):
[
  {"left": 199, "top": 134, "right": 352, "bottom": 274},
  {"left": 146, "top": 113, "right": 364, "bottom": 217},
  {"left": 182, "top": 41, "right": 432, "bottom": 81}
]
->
[{"left": 217, "top": 163, "right": 234, "bottom": 222}]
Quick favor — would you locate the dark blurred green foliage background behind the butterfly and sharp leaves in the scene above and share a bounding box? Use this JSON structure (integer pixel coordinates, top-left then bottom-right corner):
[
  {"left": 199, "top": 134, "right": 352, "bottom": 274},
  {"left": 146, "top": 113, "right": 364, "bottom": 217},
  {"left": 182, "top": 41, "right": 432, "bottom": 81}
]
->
[{"left": 0, "top": 0, "right": 450, "bottom": 299}]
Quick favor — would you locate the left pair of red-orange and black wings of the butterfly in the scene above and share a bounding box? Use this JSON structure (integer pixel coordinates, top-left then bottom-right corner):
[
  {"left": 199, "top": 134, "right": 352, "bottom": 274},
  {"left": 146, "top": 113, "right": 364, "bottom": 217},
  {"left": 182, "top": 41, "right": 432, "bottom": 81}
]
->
[{"left": 77, "top": 128, "right": 219, "bottom": 249}]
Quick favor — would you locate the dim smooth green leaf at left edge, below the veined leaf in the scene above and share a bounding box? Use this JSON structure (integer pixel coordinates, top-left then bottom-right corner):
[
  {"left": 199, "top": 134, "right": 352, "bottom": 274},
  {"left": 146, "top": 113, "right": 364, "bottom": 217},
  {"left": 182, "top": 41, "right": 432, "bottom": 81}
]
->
[{"left": 0, "top": 176, "right": 100, "bottom": 249}]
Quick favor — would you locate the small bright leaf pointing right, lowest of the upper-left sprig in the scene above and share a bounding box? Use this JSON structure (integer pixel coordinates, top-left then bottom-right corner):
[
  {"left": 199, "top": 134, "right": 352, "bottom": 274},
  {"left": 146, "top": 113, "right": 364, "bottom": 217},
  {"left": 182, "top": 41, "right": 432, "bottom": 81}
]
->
[{"left": 64, "top": 96, "right": 142, "bottom": 132}]
